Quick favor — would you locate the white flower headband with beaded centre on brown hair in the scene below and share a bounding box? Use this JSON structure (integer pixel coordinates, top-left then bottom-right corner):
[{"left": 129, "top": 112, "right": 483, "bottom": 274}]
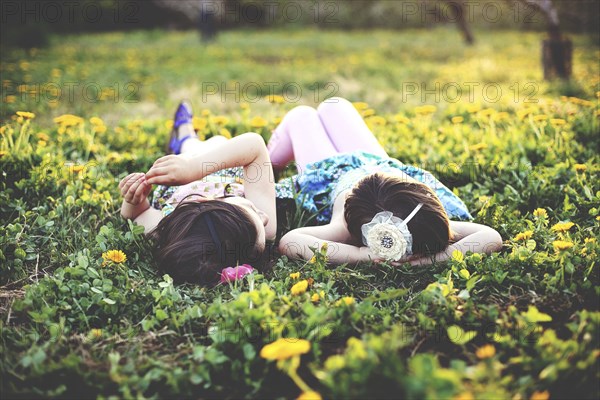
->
[{"left": 361, "top": 203, "right": 423, "bottom": 261}]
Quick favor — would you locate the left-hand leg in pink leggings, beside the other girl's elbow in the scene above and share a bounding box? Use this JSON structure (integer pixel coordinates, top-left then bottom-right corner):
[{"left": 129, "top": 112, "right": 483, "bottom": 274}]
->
[{"left": 267, "top": 106, "right": 338, "bottom": 170}]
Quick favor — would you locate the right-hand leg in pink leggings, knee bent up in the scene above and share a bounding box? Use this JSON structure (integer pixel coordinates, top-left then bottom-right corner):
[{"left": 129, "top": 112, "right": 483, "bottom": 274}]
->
[{"left": 317, "top": 97, "right": 388, "bottom": 157}]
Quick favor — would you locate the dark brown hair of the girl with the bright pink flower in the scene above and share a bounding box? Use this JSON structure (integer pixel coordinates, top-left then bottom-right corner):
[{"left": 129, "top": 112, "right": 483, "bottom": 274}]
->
[{"left": 151, "top": 200, "right": 264, "bottom": 285}]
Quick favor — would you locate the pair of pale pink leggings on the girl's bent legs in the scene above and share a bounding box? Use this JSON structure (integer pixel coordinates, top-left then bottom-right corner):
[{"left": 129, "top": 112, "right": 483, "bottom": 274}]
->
[{"left": 267, "top": 97, "right": 388, "bottom": 170}]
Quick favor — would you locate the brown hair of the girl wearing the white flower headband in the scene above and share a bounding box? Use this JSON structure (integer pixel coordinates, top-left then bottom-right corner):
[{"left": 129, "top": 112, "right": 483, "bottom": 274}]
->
[{"left": 344, "top": 173, "right": 452, "bottom": 254}]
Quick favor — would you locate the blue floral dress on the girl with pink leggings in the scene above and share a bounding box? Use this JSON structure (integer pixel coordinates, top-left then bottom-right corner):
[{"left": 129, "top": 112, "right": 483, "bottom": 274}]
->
[{"left": 278, "top": 151, "right": 473, "bottom": 223}]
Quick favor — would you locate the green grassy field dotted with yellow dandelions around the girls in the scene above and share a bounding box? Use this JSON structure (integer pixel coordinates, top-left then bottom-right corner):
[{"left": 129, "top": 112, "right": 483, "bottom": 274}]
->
[{"left": 0, "top": 28, "right": 600, "bottom": 399}]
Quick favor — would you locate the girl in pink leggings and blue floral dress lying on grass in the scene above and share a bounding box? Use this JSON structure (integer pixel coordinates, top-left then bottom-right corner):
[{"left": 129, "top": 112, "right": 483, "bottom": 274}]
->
[{"left": 267, "top": 97, "right": 502, "bottom": 265}]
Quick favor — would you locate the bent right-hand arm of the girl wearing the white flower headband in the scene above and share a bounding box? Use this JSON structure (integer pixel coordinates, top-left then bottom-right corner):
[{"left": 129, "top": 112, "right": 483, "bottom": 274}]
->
[{"left": 400, "top": 221, "right": 502, "bottom": 265}]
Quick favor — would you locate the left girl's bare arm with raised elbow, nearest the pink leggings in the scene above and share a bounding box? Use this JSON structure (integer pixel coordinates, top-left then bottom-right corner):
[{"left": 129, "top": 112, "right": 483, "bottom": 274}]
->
[{"left": 146, "top": 132, "right": 277, "bottom": 239}]
